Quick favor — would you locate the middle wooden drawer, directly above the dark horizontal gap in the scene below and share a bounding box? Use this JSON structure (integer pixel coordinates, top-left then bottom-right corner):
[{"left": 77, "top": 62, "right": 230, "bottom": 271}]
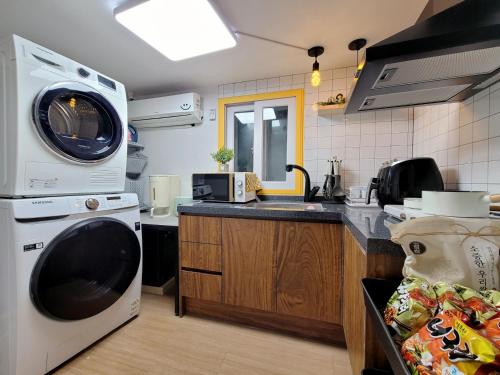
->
[{"left": 181, "top": 242, "right": 221, "bottom": 272}]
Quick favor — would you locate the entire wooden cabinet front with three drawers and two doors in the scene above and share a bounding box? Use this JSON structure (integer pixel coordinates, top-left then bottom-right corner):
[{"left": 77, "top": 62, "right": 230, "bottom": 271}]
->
[{"left": 179, "top": 214, "right": 345, "bottom": 344}]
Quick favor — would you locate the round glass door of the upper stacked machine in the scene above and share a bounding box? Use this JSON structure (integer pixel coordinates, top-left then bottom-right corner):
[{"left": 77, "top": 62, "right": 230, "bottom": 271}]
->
[{"left": 33, "top": 82, "right": 123, "bottom": 163}]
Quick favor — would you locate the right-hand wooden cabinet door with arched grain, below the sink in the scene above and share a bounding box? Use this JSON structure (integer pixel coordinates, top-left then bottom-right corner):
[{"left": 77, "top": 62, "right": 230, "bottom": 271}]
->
[{"left": 276, "top": 221, "right": 342, "bottom": 324}]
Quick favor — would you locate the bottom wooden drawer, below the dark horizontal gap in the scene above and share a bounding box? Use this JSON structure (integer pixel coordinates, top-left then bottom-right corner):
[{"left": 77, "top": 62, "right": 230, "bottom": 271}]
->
[{"left": 181, "top": 271, "right": 221, "bottom": 302}]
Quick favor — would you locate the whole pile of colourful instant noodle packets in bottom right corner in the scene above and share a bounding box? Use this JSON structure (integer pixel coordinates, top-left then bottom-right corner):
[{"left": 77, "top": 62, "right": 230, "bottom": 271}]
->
[{"left": 384, "top": 277, "right": 500, "bottom": 375}]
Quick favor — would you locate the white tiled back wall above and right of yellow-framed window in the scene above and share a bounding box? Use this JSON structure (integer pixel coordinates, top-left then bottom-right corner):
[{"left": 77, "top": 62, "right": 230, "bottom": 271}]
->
[{"left": 219, "top": 67, "right": 413, "bottom": 192}]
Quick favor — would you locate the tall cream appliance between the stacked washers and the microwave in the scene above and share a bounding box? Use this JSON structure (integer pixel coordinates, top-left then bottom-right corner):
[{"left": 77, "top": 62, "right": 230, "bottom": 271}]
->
[{"left": 149, "top": 175, "right": 181, "bottom": 217}]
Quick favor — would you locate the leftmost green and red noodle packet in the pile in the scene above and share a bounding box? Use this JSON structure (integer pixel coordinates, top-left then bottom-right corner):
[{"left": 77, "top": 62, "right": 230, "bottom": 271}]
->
[{"left": 384, "top": 277, "right": 437, "bottom": 339}]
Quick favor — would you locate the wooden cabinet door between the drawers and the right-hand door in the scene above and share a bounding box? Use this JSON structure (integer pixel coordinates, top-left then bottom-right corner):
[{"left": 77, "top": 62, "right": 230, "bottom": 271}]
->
[{"left": 222, "top": 218, "right": 277, "bottom": 311}]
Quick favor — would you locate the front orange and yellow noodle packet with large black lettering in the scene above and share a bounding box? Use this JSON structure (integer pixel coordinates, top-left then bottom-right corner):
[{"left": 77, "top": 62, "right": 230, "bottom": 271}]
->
[{"left": 401, "top": 310, "right": 500, "bottom": 375}]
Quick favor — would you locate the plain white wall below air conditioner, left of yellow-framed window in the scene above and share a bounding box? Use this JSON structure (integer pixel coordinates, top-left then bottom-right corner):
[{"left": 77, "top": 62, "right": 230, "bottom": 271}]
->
[{"left": 139, "top": 87, "right": 217, "bottom": 201}]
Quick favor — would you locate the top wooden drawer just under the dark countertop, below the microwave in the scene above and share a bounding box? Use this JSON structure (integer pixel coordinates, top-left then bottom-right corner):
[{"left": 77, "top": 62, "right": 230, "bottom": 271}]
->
[{"left": 179, "top": 215, "right": 221, "bottom": 245}]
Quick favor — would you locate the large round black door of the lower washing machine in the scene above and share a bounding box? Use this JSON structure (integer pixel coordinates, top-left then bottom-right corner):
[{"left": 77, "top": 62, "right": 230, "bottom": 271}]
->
[{"left": 30, "top": 218, "right": 141, "bottom": 320}]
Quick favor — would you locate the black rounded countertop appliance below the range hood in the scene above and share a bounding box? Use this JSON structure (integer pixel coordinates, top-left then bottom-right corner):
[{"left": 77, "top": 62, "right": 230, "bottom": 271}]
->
[{"left": 366, "top": 158, "right": 444, "bottom": 208}]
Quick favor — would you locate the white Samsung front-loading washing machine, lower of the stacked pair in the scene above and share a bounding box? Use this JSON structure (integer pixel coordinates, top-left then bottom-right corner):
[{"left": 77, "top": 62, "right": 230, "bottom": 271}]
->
[{"left": 0, "top": 194, "right": 142, "bottom": 375}]
